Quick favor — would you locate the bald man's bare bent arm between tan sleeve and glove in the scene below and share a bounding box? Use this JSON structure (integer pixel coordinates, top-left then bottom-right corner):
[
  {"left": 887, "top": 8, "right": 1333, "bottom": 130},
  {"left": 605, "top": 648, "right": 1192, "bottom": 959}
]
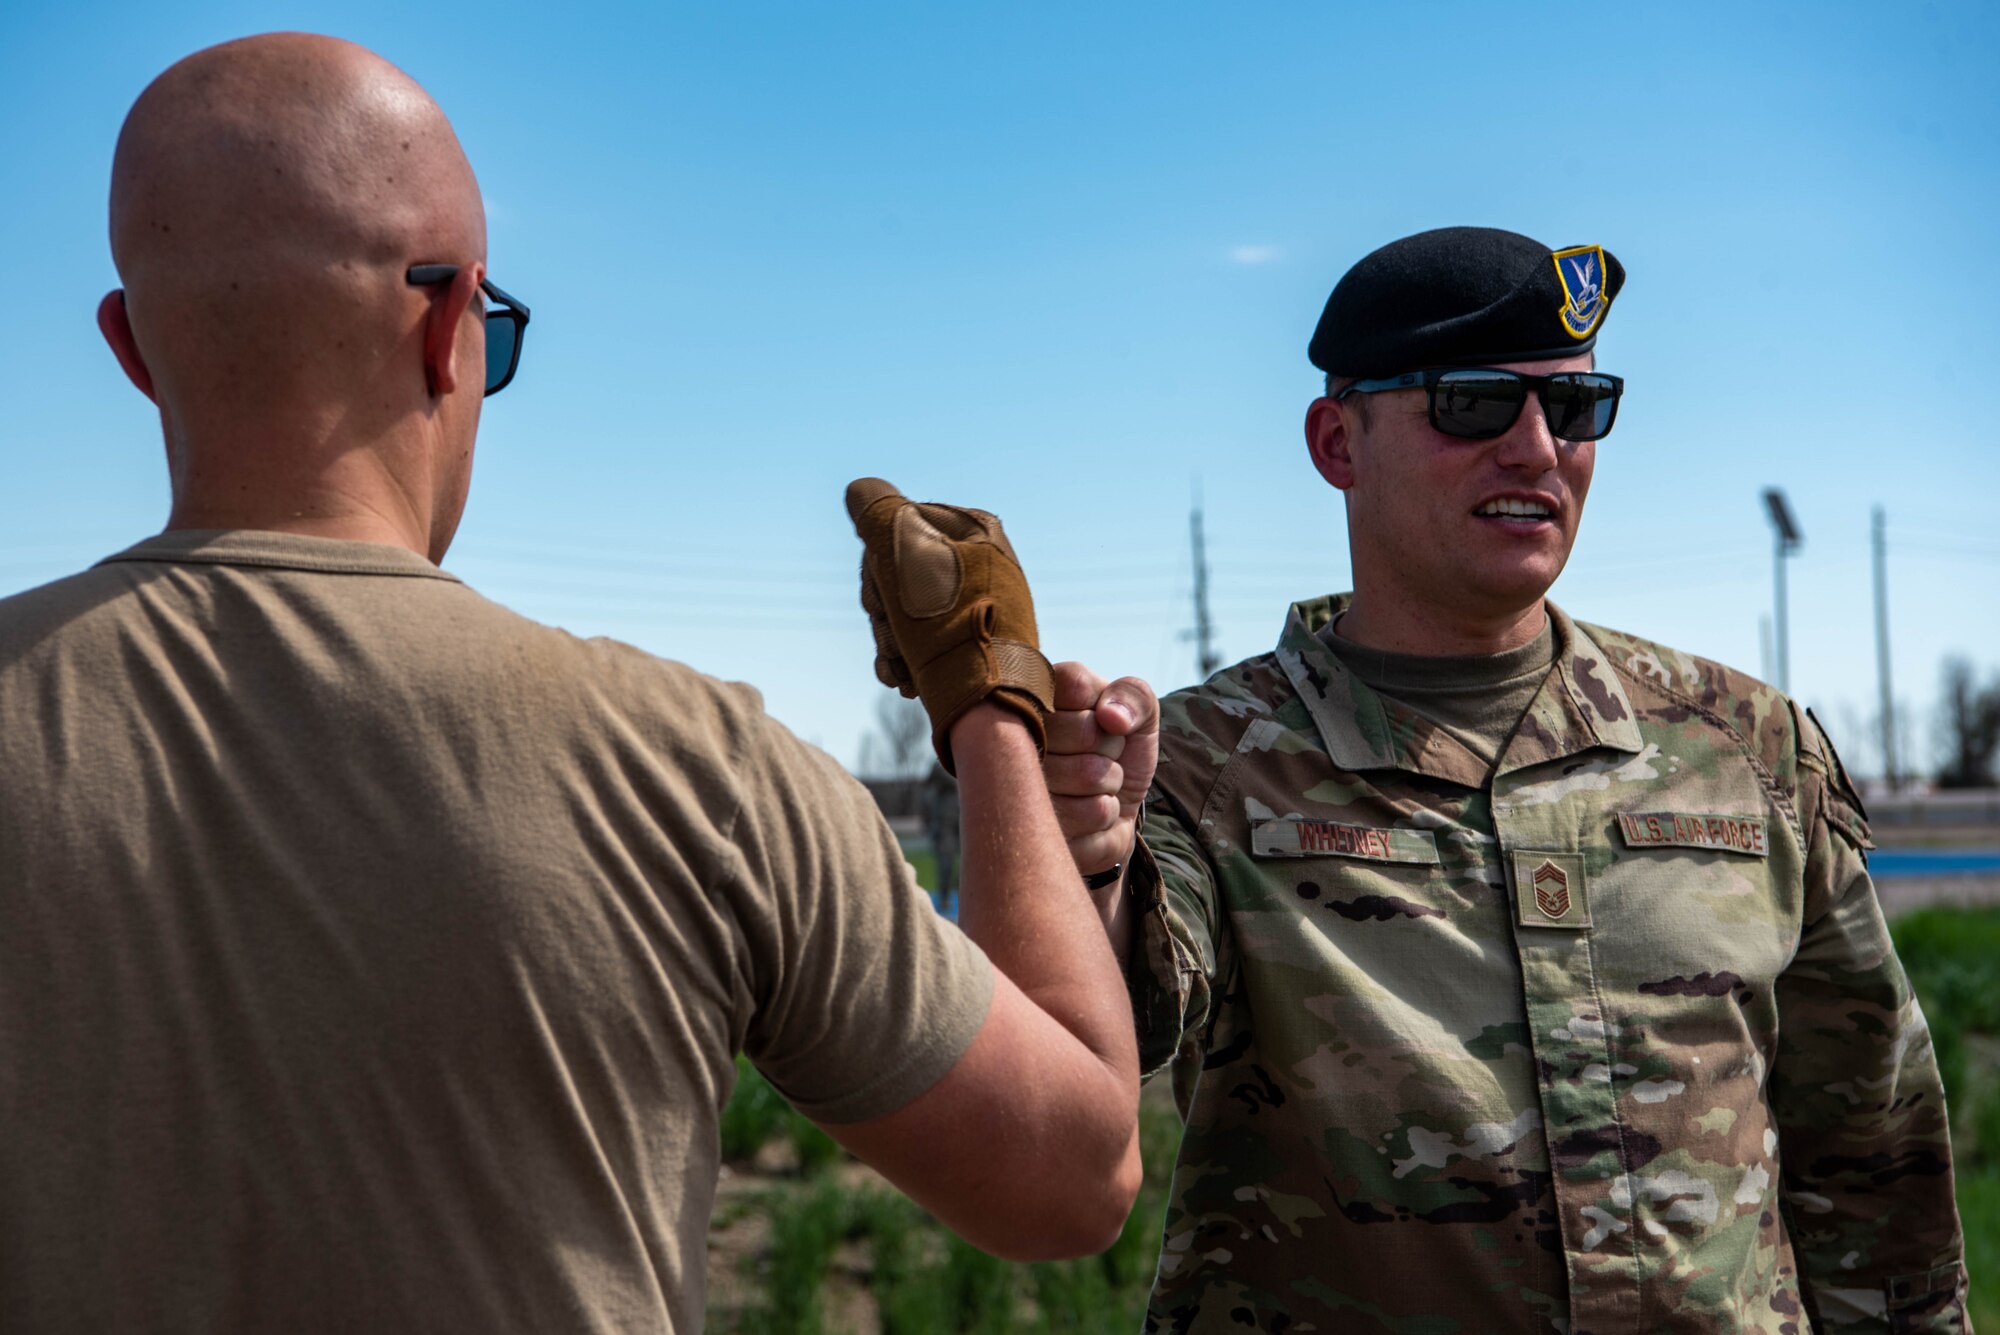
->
[{"left": 832, "top": 705, "right": 1140, "bottom": 1261}]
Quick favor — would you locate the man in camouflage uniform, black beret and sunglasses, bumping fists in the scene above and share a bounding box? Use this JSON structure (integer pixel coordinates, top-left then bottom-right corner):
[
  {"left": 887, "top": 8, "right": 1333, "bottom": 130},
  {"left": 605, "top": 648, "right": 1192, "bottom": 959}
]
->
[{"left": 1046, "top": 228, "right": 1966, "bottom": 1335}]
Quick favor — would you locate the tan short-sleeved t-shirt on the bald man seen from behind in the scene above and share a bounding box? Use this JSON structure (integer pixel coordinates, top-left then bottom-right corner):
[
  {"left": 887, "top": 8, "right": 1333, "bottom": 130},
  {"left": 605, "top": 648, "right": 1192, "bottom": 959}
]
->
[{"left": 0, "top": 532, "right": 992, "bottom": 1333}]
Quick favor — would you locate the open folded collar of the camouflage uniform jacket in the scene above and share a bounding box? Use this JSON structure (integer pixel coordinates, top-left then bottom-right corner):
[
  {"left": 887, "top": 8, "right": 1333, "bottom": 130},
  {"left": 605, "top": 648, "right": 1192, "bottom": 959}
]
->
[{"left": 1278, "top": 594, "right": 1642, "bottom": 787}]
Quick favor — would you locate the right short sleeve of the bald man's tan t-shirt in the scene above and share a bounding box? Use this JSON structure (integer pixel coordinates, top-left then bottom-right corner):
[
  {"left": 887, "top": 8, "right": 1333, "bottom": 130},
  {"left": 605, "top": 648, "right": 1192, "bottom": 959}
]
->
[{"left": 732, "top": 719, "right": 994, "bottom": 1123}]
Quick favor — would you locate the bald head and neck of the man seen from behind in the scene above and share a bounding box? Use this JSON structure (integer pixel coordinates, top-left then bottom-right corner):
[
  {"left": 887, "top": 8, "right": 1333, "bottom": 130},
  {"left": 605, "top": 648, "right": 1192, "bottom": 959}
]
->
[{"left": 106, "top": 32, "right": 500, "bottom": 563}]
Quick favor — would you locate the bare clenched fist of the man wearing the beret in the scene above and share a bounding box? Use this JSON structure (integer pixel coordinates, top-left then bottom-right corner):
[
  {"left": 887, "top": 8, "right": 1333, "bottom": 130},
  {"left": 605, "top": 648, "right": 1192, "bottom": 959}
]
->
[{"left": 1042, "top": 664, "right": 1160, "bottom": 875}]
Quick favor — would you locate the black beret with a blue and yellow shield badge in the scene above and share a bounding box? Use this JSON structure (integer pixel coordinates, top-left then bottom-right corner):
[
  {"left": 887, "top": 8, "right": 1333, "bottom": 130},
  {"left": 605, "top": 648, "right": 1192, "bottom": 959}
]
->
[{"left": 1306, "top": 228, "right": 1624, "bottom": 378}]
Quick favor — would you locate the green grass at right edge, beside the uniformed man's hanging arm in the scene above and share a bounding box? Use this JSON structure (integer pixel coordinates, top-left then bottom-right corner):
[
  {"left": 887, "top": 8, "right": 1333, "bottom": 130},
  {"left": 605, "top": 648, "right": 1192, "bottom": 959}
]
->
[{"left": 1890, "top": 907, "right": 2000, "bottom": 1331}]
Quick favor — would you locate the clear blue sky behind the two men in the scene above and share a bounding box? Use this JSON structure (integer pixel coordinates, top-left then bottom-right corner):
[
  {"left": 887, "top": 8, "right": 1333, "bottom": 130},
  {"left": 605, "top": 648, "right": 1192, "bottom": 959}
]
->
[{"left": 0, "top": 0, "right": 2000, "bottom": 771}]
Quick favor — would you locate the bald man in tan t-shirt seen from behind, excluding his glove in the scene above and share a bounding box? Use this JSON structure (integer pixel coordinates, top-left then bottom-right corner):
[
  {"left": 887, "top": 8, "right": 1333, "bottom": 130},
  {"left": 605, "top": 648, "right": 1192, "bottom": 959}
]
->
[{"left": 0, "top": 34, "right": 1138, "bottom": 1333}]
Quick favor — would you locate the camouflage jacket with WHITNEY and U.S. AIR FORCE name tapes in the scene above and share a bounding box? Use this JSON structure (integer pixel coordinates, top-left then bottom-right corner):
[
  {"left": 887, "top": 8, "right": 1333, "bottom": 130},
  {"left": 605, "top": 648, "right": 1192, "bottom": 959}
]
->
[{"left": 1128, "top": 598, "right": 1966, "bottom": 1335}]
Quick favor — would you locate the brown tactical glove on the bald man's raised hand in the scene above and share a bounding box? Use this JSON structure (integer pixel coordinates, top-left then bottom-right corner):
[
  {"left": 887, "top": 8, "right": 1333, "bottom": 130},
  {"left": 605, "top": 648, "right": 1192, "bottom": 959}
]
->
[{"left": 848, "top": 478, "right": 1056, "bottom": 773}]
